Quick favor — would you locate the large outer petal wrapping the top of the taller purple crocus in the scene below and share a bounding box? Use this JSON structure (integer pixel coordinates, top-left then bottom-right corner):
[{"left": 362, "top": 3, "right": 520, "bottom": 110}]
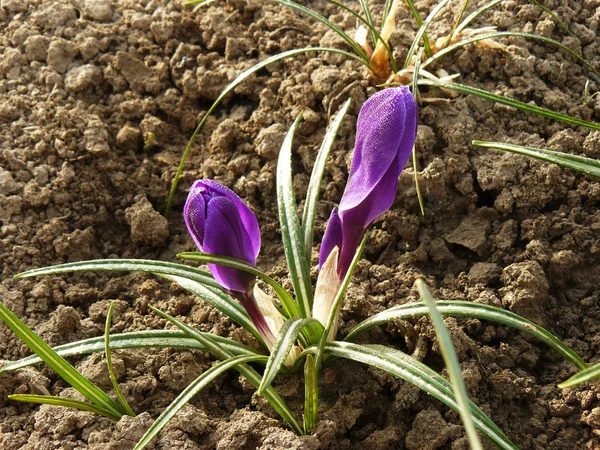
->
[{"left": 339, "top": 87, "right": 417, "bottom": 227}]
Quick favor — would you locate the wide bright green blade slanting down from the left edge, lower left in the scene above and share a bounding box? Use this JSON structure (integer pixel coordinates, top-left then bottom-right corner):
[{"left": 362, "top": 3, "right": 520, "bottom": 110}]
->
[{"left": 0, "top": 302, "right": 125, "bottom": 418}]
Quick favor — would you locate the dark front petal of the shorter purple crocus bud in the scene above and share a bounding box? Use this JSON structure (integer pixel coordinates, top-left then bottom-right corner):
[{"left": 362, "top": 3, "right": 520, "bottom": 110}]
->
[{"left": 204, "top": 197, "right": 257, "bottom": 292}]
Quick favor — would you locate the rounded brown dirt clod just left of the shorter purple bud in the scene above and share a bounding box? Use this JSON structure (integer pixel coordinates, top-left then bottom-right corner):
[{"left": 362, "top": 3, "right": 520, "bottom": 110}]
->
[{"left": 125, "top": 197, "right": 169, "bottom": 247}]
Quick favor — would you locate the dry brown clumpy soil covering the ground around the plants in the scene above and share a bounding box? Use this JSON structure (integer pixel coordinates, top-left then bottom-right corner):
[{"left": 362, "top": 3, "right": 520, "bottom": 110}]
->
[{"left": 0, "top": 0, "right": 600, "bottom": 450}]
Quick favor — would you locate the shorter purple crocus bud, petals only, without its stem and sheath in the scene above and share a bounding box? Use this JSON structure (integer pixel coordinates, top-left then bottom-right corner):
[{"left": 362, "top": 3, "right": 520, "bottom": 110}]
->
[{"left": 183, "top": 180, "right": 260, "bottom": 297}]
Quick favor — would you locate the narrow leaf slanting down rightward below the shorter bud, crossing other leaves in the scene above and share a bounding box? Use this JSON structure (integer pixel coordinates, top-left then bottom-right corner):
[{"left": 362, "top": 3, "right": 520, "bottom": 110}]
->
[{"left": 152, "top": 308, "right": 302, "bottom": 434}]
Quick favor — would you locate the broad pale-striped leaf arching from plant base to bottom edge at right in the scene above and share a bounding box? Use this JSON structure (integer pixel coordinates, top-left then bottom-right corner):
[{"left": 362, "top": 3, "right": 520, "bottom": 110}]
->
[{"left": 324, "top": 342, "right": 518, "bottom": 450}]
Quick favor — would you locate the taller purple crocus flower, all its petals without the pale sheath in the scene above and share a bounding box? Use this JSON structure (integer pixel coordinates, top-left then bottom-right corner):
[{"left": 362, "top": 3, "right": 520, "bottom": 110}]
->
[{"left": 319, "top": 86, "right": 417, "bottom": 278}]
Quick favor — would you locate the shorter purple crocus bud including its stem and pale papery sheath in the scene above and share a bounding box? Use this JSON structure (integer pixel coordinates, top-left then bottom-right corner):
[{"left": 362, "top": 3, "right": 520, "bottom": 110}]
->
[{"left": 183, "top": 180, "right": 283, "bottom": 347}]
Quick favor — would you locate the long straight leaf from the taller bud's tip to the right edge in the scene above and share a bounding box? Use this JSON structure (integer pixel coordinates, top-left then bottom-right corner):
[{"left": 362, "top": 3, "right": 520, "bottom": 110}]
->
[{"left": 419, "top": 79, "right": 600, "bottom": 130}]
